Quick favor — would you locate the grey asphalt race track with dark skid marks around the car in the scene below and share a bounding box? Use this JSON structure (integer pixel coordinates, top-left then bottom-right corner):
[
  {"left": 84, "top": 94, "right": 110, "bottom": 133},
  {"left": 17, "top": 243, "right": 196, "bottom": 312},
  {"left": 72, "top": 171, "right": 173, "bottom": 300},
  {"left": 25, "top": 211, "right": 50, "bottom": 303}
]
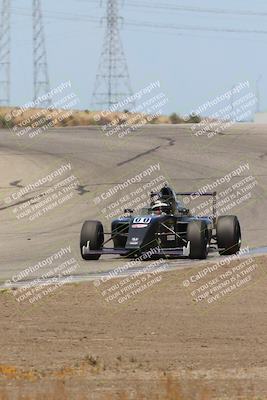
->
[{"left": 0, "top": 124, "right": 267, "bottom": 284}]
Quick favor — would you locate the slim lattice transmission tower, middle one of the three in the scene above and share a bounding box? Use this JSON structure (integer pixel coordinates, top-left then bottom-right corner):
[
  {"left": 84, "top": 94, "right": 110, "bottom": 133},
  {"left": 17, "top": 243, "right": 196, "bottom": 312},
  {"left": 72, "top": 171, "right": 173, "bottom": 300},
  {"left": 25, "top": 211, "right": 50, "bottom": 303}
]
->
[{"left": 32, "top": 0, "right": 51, "bottom": 106}]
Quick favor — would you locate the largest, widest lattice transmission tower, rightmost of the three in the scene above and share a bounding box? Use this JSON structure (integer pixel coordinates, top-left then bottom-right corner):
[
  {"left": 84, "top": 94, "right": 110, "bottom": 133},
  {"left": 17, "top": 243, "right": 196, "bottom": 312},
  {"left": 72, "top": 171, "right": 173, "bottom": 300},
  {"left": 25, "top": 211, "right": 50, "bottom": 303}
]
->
[{"left": 92, "top": 0, "right": 133, "bottom": 109}]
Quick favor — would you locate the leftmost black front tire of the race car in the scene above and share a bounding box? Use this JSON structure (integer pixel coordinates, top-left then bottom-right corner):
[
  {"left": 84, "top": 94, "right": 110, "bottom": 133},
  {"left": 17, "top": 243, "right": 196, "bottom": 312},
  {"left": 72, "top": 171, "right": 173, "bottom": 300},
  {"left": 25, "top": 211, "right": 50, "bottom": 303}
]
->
[{"left": 80, "top": 221, "right": 104, "bottom": 260}]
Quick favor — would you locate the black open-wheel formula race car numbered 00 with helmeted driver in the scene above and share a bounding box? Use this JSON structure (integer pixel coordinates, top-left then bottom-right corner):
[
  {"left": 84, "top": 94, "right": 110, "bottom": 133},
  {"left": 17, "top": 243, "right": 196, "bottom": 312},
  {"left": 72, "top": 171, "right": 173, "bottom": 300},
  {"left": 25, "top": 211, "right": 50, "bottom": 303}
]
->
[{"left": 80, "top": 186, "right": 241, "bottom": 260}]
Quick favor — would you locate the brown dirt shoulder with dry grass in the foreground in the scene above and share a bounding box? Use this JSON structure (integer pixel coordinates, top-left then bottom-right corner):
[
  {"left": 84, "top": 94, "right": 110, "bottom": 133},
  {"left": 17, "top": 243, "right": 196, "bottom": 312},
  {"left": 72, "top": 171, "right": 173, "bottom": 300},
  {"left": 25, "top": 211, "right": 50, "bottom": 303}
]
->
[{"left": 0, "top": 256, "right": 267, "bottom": 399}]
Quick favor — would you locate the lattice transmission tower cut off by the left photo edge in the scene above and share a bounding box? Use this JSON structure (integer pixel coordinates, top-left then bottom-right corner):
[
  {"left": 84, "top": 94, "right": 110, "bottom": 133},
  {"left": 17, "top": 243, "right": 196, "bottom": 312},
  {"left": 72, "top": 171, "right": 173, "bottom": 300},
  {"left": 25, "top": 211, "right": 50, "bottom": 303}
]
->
[{"left": 0, "top": 0, "right": 11, "bottom": 106}]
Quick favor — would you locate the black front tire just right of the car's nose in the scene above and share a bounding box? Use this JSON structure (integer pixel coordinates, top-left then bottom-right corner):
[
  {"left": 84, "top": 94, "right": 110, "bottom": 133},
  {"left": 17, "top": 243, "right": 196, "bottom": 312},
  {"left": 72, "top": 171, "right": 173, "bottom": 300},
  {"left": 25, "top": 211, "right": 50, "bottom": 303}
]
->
[{"left": 187, "top": 221, "right": 209, "bottom": 260}]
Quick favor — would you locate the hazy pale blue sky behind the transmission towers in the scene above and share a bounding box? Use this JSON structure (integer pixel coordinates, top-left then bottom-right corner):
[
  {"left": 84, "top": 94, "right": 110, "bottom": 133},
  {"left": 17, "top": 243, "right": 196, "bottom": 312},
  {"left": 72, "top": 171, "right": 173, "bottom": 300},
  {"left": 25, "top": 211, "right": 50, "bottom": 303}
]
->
[{"left": 11, "top": 0, "right": 267, "bottom": 113}]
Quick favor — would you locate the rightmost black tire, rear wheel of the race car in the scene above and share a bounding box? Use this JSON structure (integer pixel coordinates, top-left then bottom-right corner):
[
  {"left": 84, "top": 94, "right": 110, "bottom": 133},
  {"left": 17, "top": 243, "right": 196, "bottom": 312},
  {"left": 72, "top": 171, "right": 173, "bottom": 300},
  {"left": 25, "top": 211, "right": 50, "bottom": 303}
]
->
[{"left": 217, "top": 215, "right": 241, "bottom": 255}]
